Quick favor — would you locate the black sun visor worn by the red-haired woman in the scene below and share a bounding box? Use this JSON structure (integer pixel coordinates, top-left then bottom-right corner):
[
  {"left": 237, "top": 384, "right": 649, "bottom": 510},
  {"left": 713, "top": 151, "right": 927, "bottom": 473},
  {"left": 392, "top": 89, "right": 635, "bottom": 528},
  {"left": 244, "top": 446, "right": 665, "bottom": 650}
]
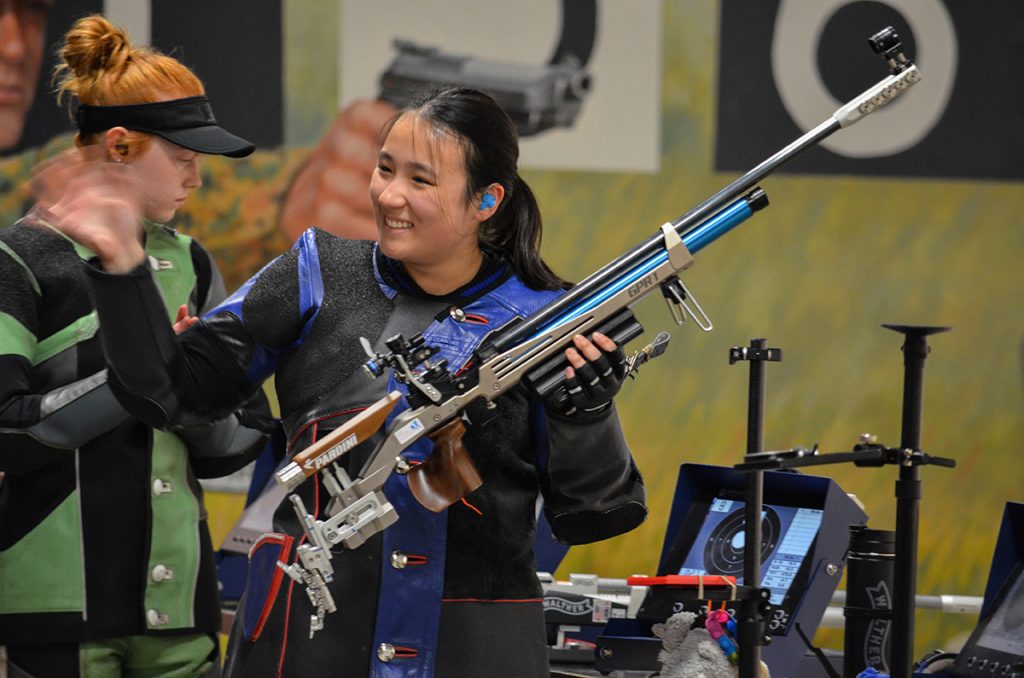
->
[{"left": 75, "top": 96, "right": 256, "bottom": 158}]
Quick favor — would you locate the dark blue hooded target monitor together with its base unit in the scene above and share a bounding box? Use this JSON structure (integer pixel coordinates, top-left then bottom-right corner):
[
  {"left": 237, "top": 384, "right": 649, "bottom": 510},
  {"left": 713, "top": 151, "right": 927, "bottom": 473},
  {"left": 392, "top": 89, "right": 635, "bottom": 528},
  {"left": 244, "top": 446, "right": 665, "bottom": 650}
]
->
[{"left": 597, "top": 464, "right": 867, "bottom": 676}]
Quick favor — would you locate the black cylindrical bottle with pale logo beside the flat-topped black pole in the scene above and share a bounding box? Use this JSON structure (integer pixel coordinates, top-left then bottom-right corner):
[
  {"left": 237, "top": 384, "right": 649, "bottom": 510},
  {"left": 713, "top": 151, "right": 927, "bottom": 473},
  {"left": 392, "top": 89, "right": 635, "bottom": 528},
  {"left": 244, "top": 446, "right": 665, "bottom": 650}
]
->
[{"left": 843, "top": 525, "right": 896, "bottom": 678}]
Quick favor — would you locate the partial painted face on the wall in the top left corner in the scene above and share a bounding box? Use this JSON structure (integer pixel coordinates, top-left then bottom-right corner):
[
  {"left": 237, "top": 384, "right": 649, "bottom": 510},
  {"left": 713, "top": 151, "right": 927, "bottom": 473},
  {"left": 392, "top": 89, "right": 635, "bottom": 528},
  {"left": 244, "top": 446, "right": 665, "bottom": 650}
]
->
[{"left": 0, "top": 0, "right": 51, "bottom": 154}]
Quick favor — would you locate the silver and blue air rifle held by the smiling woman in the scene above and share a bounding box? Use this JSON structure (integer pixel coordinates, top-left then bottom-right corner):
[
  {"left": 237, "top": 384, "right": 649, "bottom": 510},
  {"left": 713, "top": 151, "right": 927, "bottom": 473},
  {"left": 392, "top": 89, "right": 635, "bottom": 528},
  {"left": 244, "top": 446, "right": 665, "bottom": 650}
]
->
[{"left": 275, "top": 28, "right": 921, "bottom": 633}]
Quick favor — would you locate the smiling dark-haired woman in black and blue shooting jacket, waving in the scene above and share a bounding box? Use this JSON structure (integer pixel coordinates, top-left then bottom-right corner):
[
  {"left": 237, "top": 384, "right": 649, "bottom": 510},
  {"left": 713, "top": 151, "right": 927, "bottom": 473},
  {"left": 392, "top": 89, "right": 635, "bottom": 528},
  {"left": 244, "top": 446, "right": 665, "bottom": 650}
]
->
[{"left": 49, "top": 89, "right": 646, "bottom": 678}]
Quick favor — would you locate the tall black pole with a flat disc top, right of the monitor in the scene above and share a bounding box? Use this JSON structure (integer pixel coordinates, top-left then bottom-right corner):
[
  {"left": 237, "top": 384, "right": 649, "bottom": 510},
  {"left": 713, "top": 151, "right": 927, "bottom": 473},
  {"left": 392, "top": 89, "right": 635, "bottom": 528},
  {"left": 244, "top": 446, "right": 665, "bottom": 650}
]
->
[{"left": 882, "top": 325, "right": 949, "bottom": 678}]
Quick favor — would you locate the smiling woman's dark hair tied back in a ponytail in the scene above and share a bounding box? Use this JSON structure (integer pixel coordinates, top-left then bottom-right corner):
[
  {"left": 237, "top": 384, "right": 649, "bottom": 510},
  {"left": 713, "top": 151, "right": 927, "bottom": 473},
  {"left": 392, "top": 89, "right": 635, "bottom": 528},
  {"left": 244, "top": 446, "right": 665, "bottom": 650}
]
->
[{"left": 412, "top": 87, "right": 569, "bottom": 290}]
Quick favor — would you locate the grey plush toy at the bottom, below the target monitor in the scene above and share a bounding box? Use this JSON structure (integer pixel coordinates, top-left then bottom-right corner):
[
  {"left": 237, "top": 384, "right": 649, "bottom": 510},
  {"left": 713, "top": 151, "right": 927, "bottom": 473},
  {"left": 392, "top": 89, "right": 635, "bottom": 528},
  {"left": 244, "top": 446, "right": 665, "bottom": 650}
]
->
[{"left": 651, "top": 611, "right": 736, "bottom": 678}]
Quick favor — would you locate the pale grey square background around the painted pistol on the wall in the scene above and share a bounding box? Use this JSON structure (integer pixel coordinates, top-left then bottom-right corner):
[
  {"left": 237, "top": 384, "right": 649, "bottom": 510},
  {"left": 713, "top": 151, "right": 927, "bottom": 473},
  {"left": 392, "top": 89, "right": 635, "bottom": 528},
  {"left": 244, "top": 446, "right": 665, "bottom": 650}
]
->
[{"left": 338, "top": 0, "right": 662, "bottom": 172}]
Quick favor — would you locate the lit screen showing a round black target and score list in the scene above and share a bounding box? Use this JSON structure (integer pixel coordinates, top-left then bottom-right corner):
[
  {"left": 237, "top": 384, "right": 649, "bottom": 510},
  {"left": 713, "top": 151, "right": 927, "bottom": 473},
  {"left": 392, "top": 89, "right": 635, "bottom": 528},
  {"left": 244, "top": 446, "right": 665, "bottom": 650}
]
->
[{"left": 678, "top": 497, "right": 822, "bottom": 605}]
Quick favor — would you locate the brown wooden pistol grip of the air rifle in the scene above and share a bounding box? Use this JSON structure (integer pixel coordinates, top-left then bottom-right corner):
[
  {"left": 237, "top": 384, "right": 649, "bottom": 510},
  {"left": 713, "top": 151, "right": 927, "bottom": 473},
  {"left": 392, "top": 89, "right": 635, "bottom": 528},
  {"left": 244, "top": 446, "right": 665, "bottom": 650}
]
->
[{"left": 407, "top": 418, "right": 483, "bottom": 513}]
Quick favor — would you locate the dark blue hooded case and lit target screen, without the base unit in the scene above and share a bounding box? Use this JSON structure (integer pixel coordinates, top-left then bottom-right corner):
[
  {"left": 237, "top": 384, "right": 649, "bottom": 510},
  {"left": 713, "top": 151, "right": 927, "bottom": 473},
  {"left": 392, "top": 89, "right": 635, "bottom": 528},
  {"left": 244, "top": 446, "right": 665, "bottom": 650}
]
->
[{"left": 637, "top": 464, "right": 866, "bottom": 643}]
